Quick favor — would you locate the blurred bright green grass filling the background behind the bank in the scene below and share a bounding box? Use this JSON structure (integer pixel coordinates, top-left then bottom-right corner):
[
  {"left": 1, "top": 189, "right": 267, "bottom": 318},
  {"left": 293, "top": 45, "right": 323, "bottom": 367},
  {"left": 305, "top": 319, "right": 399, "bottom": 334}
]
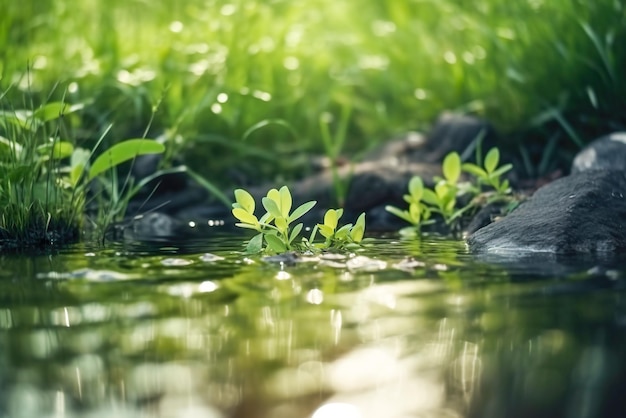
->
[{"left": 0, "top": 0, "right": 626, "bottom": 224}]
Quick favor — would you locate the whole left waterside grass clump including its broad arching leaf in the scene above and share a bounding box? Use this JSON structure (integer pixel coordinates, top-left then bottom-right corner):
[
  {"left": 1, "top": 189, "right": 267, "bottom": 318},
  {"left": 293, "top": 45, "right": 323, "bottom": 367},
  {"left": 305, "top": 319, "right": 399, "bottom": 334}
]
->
[{"left": 0, "top": 85, "right": 171, "bottom": 251}]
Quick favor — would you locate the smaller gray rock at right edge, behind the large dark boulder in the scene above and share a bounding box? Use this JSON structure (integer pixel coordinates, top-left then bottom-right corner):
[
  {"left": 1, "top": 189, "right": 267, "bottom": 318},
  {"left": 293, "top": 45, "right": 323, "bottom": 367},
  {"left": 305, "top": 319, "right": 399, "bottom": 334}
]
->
[{"left": 572, "top": 132, "right": 626, "bottom": 173}]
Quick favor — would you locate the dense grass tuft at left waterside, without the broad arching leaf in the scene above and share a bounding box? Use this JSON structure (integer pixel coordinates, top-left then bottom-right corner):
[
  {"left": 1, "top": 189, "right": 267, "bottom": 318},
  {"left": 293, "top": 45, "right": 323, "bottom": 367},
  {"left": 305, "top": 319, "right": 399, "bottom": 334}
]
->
[{"left": 0, "top": 90, "right": 85, "bottom": 251}]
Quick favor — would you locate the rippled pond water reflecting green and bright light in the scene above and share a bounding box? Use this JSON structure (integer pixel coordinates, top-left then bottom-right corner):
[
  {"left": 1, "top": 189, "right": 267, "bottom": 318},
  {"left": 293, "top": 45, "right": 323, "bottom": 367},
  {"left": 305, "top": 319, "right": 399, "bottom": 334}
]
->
[{"left": 0, "top": 236, "right": 626, "bottom": 418}]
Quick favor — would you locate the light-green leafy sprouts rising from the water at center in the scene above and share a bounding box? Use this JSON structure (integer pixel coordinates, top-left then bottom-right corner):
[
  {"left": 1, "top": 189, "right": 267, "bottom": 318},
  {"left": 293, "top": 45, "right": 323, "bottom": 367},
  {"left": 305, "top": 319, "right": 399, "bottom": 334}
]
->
[{"left": 232, "top": 186, "right": 365, "bottom": 253}]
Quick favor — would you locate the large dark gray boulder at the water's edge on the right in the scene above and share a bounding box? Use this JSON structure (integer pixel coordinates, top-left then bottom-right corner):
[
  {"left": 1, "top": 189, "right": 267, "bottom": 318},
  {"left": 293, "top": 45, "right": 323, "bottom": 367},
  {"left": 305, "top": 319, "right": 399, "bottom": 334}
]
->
[{"left": 467, "top": 170, "right": 626, "bottom": 255}]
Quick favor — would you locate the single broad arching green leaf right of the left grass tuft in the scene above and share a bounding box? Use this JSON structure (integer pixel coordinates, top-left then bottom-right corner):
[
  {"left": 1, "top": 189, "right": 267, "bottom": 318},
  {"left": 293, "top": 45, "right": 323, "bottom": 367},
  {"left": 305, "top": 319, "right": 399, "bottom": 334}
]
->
[{"left": 88, "top": 139, "right": 165, "bottom": 180}]
